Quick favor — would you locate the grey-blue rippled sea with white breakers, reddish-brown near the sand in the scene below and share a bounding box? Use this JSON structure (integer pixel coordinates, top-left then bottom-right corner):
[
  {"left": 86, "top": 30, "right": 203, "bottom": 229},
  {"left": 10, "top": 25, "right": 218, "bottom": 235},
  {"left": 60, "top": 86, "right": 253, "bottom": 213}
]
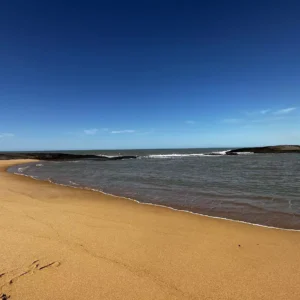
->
[{"left": 8, "top": 149, "right": 300, "bottom": 230}]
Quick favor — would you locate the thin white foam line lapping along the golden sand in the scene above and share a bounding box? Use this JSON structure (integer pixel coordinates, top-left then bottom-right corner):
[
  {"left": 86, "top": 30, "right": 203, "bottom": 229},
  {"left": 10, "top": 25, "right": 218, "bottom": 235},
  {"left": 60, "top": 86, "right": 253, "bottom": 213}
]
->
[{"left": 9, "top": 169, "right": 300, "bottom": 232}]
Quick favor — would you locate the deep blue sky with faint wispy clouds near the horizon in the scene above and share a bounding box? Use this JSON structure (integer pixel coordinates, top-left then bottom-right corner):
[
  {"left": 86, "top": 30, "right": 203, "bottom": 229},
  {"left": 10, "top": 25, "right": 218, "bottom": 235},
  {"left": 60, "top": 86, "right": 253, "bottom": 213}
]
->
[{"left": 0, "top": 0, "right": 300, "bottom": 151}]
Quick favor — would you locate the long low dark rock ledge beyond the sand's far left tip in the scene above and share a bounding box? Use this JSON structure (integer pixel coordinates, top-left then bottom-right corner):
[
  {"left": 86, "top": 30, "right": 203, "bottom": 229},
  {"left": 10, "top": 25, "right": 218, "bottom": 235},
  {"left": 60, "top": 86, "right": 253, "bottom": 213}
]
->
[{"left": 0, "top": 152, "right": 137, "bottom": 161}]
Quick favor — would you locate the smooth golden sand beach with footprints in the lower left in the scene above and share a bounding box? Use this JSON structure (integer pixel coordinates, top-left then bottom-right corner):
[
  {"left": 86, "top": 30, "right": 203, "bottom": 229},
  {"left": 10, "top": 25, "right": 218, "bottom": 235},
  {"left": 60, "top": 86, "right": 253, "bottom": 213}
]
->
[{"left": 0, "top": 161, "right": 300, "bottom": 300}]
